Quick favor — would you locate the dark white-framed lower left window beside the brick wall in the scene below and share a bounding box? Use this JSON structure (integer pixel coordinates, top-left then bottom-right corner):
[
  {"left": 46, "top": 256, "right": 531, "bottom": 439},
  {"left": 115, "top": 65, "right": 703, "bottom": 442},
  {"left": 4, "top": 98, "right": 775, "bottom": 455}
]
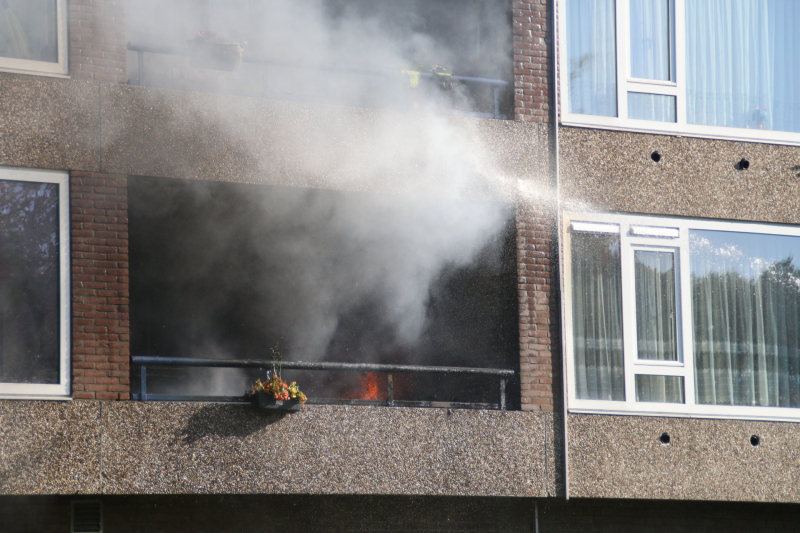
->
[{"left": 0, "top": 168, "right": 70, "bottom": 398}]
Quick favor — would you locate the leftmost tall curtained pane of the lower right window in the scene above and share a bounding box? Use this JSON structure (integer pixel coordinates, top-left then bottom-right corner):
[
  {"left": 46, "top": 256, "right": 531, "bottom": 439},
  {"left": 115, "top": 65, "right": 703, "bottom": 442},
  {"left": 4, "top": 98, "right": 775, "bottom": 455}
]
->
[{"left": 572, "top": 233, "right": 625, "bottom": 400}]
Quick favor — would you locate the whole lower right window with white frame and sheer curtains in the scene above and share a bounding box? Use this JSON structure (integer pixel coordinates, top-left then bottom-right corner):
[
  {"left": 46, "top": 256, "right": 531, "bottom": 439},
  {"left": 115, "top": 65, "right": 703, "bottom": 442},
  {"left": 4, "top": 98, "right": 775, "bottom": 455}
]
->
[{"left": 564, "top": 213, "right": 800, "bottom": 419}]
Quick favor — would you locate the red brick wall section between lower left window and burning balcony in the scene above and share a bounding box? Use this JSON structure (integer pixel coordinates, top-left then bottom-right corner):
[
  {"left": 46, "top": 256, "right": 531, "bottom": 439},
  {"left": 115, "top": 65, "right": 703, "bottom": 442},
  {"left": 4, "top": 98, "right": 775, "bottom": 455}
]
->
[{"left": 70, "top": 172, "right": 130, "bottom": 400}]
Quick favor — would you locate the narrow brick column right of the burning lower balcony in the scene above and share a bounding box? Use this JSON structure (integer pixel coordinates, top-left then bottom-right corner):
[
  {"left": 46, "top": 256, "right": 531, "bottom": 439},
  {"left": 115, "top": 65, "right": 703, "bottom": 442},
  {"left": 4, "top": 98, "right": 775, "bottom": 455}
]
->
[{"left": 517, "top": 206, "right": 561, "bottom": 411}]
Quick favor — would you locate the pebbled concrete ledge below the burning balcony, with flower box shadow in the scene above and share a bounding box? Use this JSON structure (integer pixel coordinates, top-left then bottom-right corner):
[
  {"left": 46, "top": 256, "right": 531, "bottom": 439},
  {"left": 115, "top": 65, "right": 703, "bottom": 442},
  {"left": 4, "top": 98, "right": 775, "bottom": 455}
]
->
[{"left": 0, "top": 400, "right": 554, "bottom": 497}]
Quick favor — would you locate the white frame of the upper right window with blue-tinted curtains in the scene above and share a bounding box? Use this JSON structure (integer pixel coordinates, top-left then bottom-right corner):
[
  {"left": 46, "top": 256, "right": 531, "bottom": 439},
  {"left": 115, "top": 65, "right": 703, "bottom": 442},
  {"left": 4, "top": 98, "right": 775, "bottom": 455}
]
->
[{"left": 557, "top": 0, "right": 800, "bottom": 146}]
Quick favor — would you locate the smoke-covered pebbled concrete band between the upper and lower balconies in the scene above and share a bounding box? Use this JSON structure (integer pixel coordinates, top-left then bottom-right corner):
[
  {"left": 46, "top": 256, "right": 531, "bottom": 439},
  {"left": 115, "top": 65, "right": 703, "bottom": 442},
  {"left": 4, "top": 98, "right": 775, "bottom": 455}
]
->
[{"left": 0, "top": 69, "right": 552, "bottom": 196}]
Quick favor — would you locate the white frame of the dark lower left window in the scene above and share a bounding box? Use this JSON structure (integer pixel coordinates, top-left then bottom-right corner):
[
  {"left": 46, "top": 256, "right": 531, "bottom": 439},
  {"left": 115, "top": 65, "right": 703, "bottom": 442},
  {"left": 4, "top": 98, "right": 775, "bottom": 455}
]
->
[{"left": 0, "top": 167, "right": 72, "bottom": 400}]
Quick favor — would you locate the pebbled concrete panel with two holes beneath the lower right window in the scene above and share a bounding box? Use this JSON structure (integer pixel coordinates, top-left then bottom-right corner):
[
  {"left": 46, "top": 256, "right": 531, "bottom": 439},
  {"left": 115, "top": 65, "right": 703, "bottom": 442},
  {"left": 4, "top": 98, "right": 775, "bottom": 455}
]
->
[{"left": 569, "top": 415, "right": 800, "bottom": 503}]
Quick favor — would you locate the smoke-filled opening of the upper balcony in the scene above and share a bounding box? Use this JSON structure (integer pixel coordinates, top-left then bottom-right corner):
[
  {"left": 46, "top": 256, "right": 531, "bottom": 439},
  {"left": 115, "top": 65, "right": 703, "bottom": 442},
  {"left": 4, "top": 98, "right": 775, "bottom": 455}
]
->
[{"left": 126, "top": 0, "right": 513, "bottom": 118}]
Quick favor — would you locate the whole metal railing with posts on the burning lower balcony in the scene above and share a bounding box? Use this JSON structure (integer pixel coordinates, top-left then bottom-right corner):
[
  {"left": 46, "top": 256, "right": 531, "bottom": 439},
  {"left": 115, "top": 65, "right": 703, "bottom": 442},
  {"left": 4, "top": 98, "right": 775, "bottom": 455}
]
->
[{"left": 131, "top": 355, "right": 516, "bottom": 410}]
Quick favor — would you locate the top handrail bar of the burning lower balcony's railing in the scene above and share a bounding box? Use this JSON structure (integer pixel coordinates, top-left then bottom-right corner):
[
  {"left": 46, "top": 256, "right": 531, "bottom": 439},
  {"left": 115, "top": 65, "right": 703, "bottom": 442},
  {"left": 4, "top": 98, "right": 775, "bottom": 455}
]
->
[{"left": 131, "top": 355, "right": 515, "bottom": 377}]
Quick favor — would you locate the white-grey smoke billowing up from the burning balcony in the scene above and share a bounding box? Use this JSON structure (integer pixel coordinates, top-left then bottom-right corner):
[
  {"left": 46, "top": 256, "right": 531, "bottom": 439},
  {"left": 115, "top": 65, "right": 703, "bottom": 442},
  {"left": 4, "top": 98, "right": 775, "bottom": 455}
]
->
[{"left": 127, "top": 0, "right": 520, "bottom": 400}]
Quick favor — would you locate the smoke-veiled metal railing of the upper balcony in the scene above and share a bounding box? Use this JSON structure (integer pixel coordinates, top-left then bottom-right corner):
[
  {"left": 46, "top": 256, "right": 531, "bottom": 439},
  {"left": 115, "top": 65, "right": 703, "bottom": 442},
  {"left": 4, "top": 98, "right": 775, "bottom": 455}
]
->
[{"left": 128, "top": 42, "right": 508, "bottom": 119}]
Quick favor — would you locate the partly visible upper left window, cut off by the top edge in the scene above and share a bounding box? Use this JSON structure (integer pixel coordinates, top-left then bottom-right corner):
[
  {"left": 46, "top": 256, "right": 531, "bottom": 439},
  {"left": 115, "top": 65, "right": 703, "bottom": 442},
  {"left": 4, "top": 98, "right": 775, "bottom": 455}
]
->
[{"left": 0, "top": 0, "right": 67, "bottom": 75}]
